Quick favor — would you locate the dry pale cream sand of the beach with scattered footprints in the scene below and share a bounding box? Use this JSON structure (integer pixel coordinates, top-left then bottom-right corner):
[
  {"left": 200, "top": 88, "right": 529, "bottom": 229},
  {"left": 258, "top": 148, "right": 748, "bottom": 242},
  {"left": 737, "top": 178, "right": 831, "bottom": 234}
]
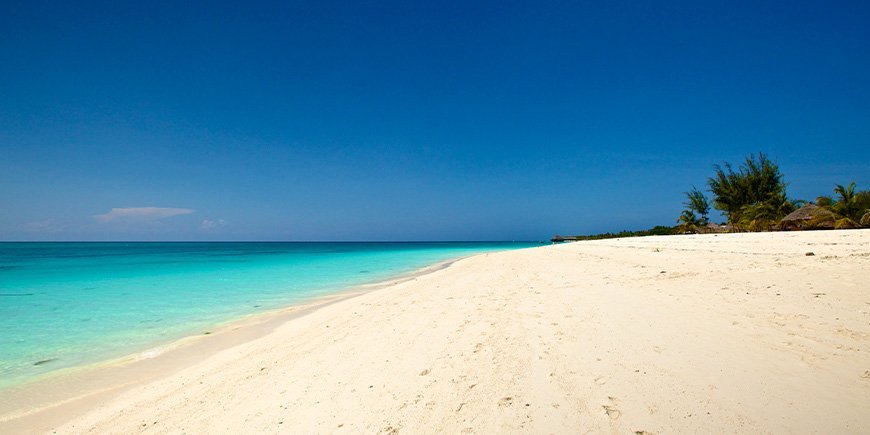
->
[{"left": 0, "top": 230, "right": 870, "bottom": 434}]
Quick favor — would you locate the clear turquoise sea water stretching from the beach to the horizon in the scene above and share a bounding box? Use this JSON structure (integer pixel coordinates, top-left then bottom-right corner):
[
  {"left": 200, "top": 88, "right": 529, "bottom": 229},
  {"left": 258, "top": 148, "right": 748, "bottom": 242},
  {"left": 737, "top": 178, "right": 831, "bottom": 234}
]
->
[{"left": 0, "top": 243, "right": 534, "bottom": 388}]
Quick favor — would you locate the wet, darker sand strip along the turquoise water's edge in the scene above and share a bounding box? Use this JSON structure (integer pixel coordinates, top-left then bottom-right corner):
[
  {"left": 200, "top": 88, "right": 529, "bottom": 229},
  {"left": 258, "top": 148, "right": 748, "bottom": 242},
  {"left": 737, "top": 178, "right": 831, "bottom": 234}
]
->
[{"left": 0, "top": 254, "right": 480, "bottom": 428}]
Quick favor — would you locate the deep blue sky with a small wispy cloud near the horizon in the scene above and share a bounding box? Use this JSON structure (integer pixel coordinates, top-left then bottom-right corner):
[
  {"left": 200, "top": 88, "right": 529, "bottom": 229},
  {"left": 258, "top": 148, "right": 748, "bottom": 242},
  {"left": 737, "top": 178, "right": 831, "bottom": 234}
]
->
[{"left": 0, "top": 0, "right": 870, "bottom": 241}]
